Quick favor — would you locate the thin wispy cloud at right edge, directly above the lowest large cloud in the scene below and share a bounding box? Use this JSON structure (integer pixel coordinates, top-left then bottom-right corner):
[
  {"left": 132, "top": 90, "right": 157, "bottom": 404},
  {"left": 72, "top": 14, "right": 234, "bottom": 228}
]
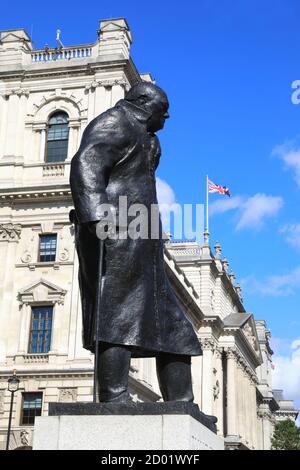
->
[{"left": 241, "top": 266, "right": 300, "bottom": 297}]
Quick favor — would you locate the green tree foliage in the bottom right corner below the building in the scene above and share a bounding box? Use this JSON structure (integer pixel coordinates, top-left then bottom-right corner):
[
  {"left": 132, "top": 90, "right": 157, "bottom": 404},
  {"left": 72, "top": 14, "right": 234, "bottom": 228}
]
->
[{"left": 272, "top": 419, "right": 300, "bottom": 450}]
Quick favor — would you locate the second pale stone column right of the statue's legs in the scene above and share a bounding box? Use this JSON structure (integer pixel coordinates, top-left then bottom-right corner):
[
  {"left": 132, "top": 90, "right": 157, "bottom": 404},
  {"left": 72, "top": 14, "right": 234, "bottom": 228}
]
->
[{"left": 227, "top": 350, "right": 237, "bottom": 436}]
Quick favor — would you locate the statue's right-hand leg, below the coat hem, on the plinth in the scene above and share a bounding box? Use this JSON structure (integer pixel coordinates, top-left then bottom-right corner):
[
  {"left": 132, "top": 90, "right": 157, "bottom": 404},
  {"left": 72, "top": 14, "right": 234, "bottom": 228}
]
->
[{"left": 156, "top": 353, "right": 194, "bottom": 402}]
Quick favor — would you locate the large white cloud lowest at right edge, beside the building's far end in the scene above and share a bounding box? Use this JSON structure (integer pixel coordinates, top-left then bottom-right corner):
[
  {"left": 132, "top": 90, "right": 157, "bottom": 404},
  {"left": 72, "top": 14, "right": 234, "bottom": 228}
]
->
[{"left": 273, "top": 338, "right": 300, "bottom": 418}]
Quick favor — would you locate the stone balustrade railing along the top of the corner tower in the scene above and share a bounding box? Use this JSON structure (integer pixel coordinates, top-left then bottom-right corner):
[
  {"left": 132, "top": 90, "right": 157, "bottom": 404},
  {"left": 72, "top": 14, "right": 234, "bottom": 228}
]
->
[{"left": 31, "top": 46, "right": 92, "bottom": 62}]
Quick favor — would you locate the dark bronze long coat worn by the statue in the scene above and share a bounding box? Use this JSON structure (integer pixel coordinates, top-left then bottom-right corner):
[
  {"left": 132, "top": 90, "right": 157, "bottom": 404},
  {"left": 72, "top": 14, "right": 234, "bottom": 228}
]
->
[{"left": 70, "top": 100, "right": 201, "bottom": 357}]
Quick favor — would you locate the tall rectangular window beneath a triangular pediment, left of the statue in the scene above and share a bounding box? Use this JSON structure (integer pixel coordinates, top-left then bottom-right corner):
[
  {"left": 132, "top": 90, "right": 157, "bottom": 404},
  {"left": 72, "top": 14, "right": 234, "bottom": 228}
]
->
[{"left": 28, "top": 306, "right": 53, "bottom": 354}]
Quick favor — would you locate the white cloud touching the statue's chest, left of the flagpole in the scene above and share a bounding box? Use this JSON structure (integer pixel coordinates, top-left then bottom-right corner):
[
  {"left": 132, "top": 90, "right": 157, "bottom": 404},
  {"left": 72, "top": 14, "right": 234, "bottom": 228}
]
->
[{"left": 156, "top": 178, "right": 181, "bottom": 231}]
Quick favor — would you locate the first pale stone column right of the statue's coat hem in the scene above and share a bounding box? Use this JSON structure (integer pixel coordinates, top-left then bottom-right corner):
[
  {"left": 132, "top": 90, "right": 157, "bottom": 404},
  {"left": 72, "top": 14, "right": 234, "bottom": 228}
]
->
[{"left": 201, "top": 338, "right": 214, "bottom": 415}]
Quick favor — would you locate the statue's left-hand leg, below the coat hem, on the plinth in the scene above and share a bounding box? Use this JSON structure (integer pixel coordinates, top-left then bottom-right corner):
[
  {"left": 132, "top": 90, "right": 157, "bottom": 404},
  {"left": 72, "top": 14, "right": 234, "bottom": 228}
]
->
[{"left": 97, "top": 343, "right": 131, "bottom": 403}]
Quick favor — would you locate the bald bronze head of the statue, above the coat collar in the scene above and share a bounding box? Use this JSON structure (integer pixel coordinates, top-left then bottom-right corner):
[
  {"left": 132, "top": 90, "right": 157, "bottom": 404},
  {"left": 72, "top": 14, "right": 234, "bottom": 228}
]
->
[{"left": 125, "top": 81, "right": 169, "bottom": 132}]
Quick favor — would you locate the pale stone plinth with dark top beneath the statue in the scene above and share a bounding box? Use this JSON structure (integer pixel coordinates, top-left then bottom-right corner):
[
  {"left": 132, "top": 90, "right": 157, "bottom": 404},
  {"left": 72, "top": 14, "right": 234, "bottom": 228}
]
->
[{"left": 33, "top": 402, "right": 224, "bottom": 450}]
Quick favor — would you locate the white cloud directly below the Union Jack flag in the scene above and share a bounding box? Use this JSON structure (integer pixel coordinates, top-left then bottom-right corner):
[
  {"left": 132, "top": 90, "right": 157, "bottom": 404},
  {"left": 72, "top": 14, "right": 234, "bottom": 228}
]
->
[{"left": 210, "top": 193, "right": 283, "bottom": 230}]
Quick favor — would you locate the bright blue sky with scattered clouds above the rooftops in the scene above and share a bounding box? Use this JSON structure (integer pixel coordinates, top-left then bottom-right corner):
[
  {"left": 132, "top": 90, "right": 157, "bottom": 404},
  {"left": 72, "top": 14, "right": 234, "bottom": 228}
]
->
[{"left": 1, "top": 0, "right": 300, "bottom": 414}]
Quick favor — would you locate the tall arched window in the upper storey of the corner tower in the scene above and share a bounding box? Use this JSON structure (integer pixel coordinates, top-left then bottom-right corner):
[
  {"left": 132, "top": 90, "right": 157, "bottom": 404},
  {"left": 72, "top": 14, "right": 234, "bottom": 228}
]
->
[{"left": 46, "top": 111, "right": 69, "bottom": 162}]
